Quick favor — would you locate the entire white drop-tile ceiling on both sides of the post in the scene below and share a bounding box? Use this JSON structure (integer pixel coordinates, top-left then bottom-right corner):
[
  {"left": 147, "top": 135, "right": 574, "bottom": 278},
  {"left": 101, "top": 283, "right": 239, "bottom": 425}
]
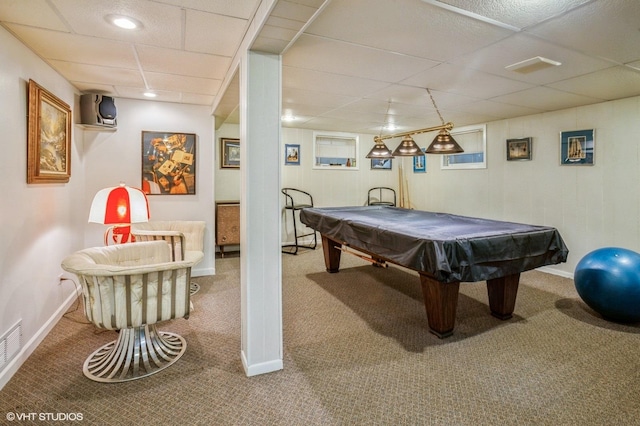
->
[{"left": 0, "top": 0, "right": 640, "bottom": 133}]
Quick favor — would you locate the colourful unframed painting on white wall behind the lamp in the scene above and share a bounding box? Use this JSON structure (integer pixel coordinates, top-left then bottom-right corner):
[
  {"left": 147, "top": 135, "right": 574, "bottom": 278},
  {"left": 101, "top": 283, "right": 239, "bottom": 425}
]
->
[{"left": 142, "top": 130, "right": 196, "bottom": 195}]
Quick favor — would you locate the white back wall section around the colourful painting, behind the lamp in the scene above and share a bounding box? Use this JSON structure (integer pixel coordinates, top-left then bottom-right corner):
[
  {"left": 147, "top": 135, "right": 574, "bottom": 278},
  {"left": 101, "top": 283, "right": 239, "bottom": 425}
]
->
[{"left": 77, "top": 99, "right": 215, "bottom": 276}]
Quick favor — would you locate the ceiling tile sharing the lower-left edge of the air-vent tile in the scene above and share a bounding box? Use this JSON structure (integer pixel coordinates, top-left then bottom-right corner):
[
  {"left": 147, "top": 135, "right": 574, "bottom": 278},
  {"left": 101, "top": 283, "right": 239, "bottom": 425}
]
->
[{"left": 402, "top": 63, "right": 534, "bottom": 98}]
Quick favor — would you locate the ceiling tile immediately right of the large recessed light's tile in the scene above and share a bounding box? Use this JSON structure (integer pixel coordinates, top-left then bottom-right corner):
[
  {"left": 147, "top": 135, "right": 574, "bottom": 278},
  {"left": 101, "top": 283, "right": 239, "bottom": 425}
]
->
[{"left": 185, "top": 10, "right": 248, "bottom": 57}]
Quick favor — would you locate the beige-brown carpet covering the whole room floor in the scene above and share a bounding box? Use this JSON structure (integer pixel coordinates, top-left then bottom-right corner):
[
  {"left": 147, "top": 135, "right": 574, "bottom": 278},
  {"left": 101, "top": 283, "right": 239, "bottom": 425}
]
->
[{"left": 0, "top": 250, "right": 640, "bottom": 425}]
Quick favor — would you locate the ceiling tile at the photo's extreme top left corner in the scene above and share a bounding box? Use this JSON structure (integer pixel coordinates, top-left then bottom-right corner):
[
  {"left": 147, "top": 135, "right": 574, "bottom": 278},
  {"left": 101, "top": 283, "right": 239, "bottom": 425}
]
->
[{"left": 0, "top": 0, "right": 69, "bottom": 32}]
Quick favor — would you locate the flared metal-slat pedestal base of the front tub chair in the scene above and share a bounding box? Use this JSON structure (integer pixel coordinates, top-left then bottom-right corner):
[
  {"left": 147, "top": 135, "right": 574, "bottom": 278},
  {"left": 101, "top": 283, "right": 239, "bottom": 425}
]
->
[{"left": 82, "top": 324, "right": 187, "bottom": 383}]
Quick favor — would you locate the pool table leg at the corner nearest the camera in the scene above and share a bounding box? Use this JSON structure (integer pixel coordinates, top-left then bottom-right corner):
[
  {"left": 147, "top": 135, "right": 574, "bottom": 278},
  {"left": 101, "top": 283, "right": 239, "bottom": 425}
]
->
[{"left": 420, "top": 274, "right": 460, "bottom": 339}]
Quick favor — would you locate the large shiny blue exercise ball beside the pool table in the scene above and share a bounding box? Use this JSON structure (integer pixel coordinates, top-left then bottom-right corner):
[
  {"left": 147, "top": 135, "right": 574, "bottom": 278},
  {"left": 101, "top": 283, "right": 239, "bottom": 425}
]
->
[{"left": 573, "top": 247, "right": 640, "bottom": 323}]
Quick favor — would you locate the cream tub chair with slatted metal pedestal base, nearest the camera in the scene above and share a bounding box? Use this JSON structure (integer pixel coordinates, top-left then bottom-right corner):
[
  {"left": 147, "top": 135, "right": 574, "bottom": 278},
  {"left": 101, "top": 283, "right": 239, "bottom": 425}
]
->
[{"left": 62, "top": 241, "right": 199, "bottom": 382}]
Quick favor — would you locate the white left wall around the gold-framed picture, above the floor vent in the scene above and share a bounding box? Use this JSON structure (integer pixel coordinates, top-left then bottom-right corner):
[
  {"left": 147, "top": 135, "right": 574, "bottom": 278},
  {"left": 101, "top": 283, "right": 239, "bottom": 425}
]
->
[{"left": 0, "top": 28, "right": 86, "bottom": 388}]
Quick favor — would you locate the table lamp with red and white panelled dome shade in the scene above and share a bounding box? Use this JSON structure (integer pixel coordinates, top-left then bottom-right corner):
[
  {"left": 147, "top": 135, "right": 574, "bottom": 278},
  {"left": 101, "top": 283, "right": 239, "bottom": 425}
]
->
[{"left": 89, "top": 183, "right": 149, "bottom": 245}]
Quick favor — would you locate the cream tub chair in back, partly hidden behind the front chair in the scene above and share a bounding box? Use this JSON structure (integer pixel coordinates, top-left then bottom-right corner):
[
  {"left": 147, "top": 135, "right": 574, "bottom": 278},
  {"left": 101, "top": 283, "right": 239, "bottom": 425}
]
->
[{"left": 131, "top": 220, "right": 206, "bottom": 296}]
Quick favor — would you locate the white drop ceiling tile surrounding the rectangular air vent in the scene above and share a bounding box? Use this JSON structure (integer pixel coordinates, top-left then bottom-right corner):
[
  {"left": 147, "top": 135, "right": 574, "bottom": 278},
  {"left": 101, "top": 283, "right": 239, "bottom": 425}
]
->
[{"left": 451, "top": 33, "right": 611, "bottom": 84}]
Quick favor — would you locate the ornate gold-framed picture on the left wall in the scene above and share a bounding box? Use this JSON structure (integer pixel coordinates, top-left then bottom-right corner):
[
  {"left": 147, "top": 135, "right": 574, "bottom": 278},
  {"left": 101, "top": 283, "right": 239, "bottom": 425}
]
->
[{"left": 27, "top": 80, "right": 71, "bottom": 183}]
